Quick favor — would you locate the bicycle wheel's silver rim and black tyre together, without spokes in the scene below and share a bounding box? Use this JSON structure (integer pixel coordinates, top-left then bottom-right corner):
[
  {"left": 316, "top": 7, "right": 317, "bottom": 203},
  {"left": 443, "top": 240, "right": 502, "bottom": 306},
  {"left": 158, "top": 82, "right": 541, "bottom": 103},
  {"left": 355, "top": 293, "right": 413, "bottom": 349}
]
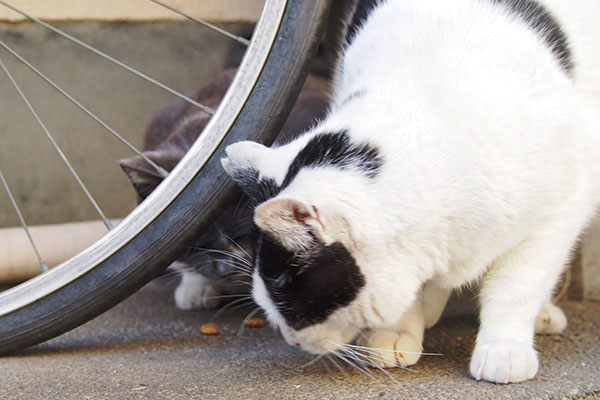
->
[{"left": 0, "top": 0, "right": 329, "bottom": 353}]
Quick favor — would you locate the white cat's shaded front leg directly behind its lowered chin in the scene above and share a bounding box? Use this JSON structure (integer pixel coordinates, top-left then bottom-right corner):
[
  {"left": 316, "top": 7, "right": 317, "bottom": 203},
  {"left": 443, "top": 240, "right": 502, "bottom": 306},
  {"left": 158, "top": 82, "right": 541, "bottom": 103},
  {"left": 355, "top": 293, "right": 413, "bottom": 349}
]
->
[{"left": 358, "top": 293, "right": 425, "bottom": 368}]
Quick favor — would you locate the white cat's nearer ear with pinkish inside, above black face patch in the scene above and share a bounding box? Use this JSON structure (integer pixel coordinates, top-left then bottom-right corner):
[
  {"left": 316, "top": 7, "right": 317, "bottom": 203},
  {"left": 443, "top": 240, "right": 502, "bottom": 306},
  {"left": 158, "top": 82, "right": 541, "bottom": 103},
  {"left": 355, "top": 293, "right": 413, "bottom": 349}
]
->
[{"left": 254, "top": 198, "right": 325, "bottom": 250}]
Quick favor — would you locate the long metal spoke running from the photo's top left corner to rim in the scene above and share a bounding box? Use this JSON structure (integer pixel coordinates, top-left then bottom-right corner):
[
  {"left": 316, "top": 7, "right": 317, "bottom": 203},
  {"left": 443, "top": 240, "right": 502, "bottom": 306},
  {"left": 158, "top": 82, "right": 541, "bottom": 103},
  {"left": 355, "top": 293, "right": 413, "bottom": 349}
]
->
[{"left": 0, "top": 0, "right": 215, "bottom": 116}]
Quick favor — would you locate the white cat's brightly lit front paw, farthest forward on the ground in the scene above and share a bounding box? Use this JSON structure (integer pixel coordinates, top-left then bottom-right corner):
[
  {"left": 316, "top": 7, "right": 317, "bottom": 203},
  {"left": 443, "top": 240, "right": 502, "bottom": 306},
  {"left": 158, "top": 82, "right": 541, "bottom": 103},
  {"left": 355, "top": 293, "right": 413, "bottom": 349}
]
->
[{"left": 471, "top": 340, "right": 539, "bottom": 383}]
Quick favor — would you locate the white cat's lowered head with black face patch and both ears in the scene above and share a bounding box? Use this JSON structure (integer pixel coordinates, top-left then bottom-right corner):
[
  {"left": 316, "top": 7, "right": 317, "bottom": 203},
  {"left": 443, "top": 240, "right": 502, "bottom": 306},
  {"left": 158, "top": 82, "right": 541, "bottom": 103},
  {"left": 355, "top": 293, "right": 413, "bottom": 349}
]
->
[{"left": 222, "top": 135, "right": 418, "bottom": 354}]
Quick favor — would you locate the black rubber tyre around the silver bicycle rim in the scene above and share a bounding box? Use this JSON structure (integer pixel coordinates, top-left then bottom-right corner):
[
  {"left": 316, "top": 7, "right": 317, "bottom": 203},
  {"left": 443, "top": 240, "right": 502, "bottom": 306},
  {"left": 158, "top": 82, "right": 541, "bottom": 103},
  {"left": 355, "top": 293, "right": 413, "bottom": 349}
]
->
[{"left": 0, "top": 0, "right": 330, "bottom": 354}]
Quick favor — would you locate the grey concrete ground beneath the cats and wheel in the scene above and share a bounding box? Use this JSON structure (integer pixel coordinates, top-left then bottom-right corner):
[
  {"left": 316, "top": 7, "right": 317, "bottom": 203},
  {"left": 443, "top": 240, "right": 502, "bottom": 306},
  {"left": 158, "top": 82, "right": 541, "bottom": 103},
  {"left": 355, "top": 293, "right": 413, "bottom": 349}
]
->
[{"left": 0, "top": 284, "right": 600, "bottom": 400}]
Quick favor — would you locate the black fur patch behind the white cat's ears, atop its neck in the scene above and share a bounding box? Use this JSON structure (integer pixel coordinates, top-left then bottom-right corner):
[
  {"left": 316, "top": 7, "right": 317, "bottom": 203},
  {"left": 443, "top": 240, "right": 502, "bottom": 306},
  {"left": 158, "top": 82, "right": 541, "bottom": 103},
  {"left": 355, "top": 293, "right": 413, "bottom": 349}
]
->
[{"left": 281, "top": 131, "right": 383, "bottom": 189}]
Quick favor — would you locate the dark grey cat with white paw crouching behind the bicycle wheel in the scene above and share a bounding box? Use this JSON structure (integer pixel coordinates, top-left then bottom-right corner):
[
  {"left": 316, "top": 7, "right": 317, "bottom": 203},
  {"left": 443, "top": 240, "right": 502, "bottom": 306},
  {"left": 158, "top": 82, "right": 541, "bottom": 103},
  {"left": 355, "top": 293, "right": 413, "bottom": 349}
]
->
[{"left": 120, "top": 69, "right": 329, "bottom": 310}]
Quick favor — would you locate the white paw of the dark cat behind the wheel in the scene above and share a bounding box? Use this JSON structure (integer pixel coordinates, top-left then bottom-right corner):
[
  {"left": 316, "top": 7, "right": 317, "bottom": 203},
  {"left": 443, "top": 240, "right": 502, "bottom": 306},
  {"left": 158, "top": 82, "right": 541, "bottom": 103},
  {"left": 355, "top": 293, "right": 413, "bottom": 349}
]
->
[{"left": 175, "top": 273, "right": 221, "bottom": 310}]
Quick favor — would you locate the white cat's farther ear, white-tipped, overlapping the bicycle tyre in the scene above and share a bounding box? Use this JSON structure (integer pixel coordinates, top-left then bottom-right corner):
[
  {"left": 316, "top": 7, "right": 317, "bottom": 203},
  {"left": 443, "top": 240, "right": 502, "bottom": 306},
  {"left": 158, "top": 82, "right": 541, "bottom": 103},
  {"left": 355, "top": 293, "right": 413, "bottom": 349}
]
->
[{"left": 221, "top": 141, "right": 269, "bottom": 200}]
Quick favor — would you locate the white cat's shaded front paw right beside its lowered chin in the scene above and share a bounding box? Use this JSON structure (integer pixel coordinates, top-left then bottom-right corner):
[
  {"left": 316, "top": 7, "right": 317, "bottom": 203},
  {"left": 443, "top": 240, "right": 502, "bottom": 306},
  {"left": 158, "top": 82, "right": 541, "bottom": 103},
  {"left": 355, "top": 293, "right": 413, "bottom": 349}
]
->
[{"left": 358, "top": 330, "right": 423, "bottom": 368}]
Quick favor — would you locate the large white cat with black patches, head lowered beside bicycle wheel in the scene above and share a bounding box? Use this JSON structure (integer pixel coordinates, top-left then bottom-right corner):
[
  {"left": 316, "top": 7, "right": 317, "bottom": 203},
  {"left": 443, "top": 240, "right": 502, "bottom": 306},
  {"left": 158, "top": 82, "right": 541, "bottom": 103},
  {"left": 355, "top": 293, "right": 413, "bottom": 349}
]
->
[{"left": 223, "top": 0, "right": 600, "bottom": 383}]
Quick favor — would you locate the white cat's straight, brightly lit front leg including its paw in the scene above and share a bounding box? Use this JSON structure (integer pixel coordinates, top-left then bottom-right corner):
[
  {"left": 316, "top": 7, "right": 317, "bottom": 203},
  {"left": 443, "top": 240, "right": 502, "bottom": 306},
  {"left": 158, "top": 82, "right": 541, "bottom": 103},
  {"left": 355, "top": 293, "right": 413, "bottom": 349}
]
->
[{"left": 470, "top": 222, "right": 578, "bottom": 383}]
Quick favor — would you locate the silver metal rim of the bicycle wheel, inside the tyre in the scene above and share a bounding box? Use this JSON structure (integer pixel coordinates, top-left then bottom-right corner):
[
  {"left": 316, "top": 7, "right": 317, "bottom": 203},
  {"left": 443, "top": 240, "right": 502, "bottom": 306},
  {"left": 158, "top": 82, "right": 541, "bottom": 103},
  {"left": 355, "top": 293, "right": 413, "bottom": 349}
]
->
[{"left": 0, "top": 0, "right": 287, "bottom": 317}]
